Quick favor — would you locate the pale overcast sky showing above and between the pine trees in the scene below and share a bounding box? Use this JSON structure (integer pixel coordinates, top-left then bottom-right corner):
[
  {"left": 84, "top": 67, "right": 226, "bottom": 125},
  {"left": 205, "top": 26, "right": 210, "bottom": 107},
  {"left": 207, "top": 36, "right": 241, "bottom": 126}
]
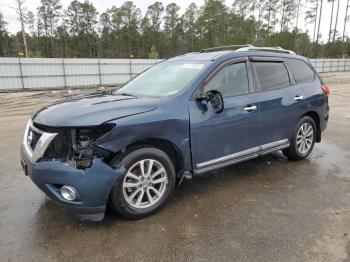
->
[{"left": 0, "top": 0, "right": 350, "bottom": 42}]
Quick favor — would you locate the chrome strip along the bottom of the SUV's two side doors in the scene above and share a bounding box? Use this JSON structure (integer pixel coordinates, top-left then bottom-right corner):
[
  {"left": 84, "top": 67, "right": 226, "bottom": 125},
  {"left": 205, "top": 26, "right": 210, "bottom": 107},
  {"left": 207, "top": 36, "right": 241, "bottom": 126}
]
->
[{"left": 196, "top": 139, "right": 289, "bottom": 169}]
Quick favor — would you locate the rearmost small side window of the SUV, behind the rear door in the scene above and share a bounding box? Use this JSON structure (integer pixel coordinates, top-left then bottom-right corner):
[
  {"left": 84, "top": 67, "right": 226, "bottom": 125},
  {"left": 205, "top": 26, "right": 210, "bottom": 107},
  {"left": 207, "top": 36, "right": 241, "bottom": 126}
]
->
[{"left": 286, "top": 59, "right": 315, "bottom": 83}]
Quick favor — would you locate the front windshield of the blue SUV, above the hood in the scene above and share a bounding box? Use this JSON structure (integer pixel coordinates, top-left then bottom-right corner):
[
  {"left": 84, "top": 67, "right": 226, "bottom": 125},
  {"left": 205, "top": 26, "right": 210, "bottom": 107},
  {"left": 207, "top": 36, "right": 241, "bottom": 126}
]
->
[{"left": 114, "top": 61, "right": 208, "bottom": 96}]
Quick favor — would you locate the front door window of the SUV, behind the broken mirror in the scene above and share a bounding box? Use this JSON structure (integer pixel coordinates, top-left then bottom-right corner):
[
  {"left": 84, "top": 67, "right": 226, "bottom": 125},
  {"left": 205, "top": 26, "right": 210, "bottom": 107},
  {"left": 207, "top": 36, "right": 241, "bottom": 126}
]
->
[{"left": 204, "top": 62, "right": 249, "bottom": 97}]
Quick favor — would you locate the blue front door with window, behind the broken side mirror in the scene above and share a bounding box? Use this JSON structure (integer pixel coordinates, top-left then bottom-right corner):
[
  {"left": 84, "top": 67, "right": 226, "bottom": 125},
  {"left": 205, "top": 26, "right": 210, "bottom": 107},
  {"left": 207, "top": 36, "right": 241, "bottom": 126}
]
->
[{"left": 189, "top": 58, "right": 260, "bottom": 173}]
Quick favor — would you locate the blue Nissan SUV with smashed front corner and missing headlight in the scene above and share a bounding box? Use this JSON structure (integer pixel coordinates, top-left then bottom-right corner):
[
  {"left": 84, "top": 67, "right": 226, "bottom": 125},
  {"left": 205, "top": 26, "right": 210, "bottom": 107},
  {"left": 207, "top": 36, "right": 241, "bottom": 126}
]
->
[{"left": 21, "top": 46, "right": 329, "bottom": 221}]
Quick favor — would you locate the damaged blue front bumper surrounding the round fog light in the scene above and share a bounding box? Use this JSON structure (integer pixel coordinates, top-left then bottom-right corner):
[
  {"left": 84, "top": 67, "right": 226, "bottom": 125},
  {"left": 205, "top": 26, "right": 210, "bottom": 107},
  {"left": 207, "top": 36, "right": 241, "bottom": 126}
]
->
[{"left": 21, "top": 146, "right": 122, "bottom": 221}]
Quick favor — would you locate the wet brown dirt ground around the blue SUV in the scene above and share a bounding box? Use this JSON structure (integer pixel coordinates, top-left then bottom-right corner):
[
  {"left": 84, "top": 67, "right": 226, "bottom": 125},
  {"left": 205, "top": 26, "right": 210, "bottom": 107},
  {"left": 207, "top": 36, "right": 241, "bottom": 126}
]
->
[{"left": 0, "top": 73, "right": 350, "bottom": 261}]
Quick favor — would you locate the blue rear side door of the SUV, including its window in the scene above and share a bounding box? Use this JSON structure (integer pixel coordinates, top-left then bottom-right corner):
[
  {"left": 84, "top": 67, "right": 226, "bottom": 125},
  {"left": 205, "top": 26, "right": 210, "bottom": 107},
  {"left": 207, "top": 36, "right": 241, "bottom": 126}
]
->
[{"left": 250, "top": 57, "right": 303, "bottom": 151}]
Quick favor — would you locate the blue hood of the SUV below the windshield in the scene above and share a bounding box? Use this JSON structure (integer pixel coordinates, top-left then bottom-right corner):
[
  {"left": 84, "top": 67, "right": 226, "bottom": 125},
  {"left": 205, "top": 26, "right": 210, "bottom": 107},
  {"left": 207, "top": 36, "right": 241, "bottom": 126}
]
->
[{"left": 33, "top": 94, "right": 160, "bottom": 127}]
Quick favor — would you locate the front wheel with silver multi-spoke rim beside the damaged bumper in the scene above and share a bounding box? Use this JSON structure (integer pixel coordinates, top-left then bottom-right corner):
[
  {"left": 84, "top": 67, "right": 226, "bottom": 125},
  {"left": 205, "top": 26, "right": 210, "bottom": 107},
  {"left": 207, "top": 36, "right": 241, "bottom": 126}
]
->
[{"left": 110, "top": 146, "right": 176, "bottom": 219}]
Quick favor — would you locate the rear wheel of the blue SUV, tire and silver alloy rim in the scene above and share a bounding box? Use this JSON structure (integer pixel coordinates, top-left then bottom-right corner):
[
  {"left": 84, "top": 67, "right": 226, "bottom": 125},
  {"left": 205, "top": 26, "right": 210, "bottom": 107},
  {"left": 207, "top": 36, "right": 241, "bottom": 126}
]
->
[{"left": 283, "top": 116, "right": 317, "bottom": 160}]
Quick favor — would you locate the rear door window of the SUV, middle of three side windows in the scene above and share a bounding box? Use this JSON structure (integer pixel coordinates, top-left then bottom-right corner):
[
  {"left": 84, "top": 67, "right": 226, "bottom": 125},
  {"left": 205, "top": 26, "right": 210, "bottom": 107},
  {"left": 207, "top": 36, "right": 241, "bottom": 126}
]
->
[{"left": 252, "top": 62, "right": 290, "bottom": 91}]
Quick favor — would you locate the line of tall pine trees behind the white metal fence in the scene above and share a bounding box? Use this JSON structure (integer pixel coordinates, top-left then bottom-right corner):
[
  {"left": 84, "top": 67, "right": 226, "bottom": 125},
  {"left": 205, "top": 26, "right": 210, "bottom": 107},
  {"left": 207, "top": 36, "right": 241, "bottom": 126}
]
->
[{"left": 0, "top": 0, "right": 350, "bottom": 58}]
